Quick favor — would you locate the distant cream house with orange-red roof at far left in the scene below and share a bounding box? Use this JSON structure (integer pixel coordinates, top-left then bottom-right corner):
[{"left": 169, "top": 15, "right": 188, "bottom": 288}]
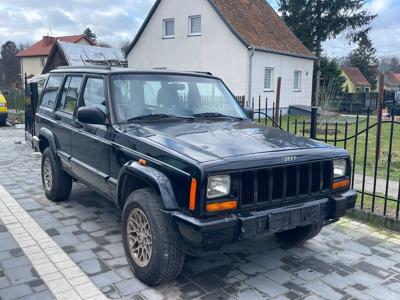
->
[{"left": 17, "top": 35, "right": 90, "bottom": 78}]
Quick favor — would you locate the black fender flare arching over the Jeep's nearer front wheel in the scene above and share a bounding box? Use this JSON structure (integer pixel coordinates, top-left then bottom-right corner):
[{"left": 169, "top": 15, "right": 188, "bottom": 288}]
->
[{"left": 117, "top": 162, "right": 178, "bottom": 210}]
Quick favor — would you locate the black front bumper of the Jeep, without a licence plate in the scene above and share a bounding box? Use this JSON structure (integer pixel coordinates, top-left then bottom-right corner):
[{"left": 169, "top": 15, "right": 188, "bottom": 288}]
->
[{"left": 171, "top": 190, "right": 357, "bottom": 256}]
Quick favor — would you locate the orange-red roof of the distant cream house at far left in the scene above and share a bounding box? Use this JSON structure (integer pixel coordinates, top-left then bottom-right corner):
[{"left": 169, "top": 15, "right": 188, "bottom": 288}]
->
[{"left": 17, "top": 35, "right": 89, "bottom": 57}]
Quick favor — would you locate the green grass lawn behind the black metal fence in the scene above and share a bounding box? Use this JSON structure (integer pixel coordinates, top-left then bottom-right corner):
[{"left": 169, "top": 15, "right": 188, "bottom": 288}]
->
[{"left": 261, "top": 116, "right": 400, "bottom": 181}]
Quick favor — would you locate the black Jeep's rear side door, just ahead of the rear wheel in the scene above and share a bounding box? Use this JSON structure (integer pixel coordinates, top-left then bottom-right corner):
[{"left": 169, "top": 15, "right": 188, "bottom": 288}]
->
[{"left": 53, "top": 75, "right": 82, "bottom": 170}]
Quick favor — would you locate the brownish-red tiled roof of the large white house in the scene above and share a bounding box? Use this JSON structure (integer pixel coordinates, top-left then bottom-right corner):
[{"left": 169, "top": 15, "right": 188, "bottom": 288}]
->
[{"left": 210, "top": 0, "right": 313, "bottom": 57}]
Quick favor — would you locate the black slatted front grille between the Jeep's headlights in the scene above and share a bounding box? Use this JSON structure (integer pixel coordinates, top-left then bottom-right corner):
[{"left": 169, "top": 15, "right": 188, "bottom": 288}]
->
[{"left": 239, "top": 161, "right": 333, "bottom": 205}]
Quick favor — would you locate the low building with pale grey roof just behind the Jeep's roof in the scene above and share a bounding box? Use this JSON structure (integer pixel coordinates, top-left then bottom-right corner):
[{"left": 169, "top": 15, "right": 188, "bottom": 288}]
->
[{"left": 42, "top": 41, "right": 128, "bottom": 74}]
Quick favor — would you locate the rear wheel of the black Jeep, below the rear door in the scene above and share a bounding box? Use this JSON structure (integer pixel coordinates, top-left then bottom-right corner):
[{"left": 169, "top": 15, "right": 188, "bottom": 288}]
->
[{"left": 42, "top": 147, "right": 72, "bottom": 202}]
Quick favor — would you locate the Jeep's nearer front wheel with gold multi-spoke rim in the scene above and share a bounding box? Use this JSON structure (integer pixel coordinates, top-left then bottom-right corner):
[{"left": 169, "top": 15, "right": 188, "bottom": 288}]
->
[{"left": 122, "top": 188, "right": 185, "bottom": 286}]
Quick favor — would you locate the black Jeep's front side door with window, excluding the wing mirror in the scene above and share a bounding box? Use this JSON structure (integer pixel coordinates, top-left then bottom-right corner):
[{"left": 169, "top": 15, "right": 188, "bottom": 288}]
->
[{"left": 72, "top": 76, "right": 111, "bottom": 196}]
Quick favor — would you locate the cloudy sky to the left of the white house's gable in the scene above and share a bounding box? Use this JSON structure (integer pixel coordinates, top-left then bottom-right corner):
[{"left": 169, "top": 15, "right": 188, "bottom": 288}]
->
[{"left": 0, "top": 0, "right": 155, "bottom": 47}]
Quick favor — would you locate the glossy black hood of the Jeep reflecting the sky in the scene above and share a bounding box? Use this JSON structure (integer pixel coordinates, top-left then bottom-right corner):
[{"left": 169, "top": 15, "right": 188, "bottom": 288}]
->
[{"left": 127, "top": 121, "right": 330, "bottom": 162}]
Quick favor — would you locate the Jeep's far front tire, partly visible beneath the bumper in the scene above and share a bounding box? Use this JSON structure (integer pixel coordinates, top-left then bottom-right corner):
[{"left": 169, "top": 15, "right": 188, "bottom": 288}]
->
[{"left": 275, "top": 224, "right": 322, "bottom": 245}]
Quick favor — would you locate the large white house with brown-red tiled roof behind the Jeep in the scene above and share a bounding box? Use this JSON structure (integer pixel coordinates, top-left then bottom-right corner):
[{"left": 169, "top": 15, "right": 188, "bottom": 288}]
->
[{"left": 127, "top": 0, "right": 315, "bottom": 108}]
